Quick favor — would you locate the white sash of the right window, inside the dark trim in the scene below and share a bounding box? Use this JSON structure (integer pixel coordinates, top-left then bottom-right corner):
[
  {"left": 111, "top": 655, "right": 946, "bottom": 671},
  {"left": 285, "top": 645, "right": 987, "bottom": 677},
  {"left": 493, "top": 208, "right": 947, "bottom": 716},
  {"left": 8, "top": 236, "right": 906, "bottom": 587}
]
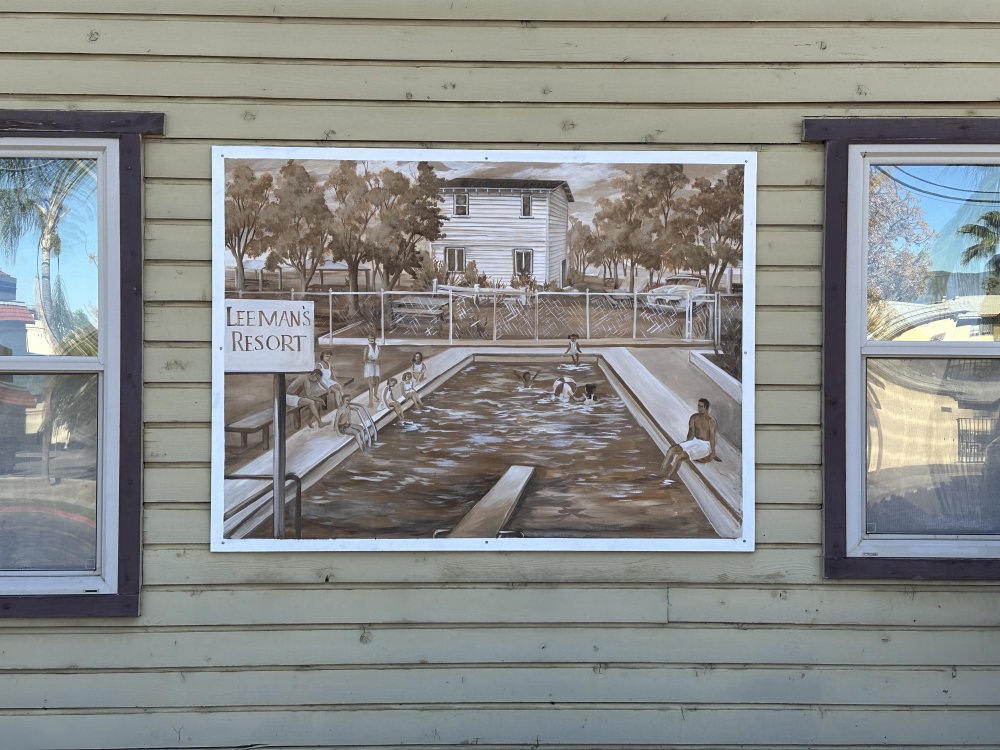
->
[{"left": 844, "top": 144, "right": 1000, "bottom": 559}]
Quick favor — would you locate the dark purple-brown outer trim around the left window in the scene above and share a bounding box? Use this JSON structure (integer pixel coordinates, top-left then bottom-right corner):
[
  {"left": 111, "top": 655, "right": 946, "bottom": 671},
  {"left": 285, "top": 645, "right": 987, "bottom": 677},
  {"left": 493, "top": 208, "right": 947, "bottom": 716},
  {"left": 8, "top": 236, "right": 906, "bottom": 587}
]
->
[{"left": 0, "top": 110, "right": 163, "bottom": 617}]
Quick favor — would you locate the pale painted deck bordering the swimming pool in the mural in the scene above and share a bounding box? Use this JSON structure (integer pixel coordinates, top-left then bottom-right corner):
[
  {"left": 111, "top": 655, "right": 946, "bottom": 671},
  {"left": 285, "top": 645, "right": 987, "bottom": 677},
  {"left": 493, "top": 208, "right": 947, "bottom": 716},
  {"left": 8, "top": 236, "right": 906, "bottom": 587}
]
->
[{"left": 224, "top": 342, "right": 742, "bottom": 537}]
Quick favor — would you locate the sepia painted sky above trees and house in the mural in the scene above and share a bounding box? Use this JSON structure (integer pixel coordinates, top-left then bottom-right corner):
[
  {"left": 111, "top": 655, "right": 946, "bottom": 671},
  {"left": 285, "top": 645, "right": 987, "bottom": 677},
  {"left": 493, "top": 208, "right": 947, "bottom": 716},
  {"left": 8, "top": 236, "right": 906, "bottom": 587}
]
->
[{"left": 226, "top": 159, "right": 730, "bottom": 224}]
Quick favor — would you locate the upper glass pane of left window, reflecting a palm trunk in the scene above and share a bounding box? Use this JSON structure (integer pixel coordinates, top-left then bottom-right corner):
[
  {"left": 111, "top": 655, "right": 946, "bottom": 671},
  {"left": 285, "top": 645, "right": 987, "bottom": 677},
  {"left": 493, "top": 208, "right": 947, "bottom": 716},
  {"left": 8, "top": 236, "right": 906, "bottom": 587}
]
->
[{"left": 0, "top": 156, "right": 99, "bottom": 355}]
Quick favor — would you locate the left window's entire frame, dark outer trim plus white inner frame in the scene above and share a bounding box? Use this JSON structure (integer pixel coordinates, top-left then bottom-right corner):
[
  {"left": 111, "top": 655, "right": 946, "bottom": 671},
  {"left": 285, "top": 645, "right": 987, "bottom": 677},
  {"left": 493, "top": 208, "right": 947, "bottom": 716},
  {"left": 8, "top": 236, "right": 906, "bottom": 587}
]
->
[{"left": 0, "top": 110, "right": 163, "bottom": 617}]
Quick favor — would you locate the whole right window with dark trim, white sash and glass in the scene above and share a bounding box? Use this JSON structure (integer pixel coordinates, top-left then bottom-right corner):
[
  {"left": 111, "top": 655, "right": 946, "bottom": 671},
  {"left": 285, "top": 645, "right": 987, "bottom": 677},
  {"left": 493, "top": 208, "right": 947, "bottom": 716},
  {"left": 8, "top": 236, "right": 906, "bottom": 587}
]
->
[{"left": 806, "top": 120, "right": 1000, "bottom": 578}]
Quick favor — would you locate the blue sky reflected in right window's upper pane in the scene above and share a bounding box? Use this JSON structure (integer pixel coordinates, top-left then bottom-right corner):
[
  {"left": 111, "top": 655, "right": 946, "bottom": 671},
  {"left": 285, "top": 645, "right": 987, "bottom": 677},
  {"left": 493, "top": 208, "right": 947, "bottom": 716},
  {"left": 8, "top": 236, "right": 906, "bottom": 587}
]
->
[{"left": 882, "top": 164, "right": 1000, "bottom": 272}]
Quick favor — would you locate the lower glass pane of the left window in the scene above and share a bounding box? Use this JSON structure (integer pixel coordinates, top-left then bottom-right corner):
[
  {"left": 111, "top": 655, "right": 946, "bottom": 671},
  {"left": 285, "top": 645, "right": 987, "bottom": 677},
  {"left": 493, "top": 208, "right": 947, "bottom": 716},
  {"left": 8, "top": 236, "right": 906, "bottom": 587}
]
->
[{"left": 0, "top": 374, "right": 98, "bottom": 571}]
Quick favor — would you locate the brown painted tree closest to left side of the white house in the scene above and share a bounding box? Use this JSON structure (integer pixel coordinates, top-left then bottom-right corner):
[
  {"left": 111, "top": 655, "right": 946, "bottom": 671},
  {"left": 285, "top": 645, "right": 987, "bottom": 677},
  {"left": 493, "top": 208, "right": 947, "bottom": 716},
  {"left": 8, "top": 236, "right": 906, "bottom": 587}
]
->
[{"left": 366, "top": 162, "right": 444, "bottom": 289}]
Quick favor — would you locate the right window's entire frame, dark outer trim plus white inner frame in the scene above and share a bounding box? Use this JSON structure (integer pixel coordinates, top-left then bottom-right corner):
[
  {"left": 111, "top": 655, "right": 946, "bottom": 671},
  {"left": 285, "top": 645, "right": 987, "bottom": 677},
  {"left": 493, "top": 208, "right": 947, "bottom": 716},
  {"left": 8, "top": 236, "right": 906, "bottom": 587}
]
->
[{"left": 804, "top": 118, "right": 1000, "bottom": 580}]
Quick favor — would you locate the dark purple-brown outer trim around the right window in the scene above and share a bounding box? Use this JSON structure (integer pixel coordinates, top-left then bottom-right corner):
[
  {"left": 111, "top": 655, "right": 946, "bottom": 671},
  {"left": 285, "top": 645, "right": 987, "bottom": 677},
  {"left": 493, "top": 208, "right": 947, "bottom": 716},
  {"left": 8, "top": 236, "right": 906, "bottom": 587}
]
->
[{"left": 803, "top": 117, "right": 1000, "bottom": 580}]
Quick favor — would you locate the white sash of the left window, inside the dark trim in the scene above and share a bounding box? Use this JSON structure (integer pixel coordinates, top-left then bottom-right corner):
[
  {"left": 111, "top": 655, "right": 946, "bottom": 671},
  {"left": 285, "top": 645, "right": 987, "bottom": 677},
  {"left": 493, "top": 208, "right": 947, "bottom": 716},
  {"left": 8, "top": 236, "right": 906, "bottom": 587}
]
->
[{"left": 0, "top": 136, "right": 121, "bottom": 596}]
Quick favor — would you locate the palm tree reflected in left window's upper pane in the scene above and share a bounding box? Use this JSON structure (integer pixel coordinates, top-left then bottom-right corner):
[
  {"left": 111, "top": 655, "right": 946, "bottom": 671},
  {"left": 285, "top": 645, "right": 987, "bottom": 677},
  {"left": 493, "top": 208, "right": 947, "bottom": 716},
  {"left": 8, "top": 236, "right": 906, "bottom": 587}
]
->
[{"left": 0, "top": 157, "right": 97, "bottom": 325}]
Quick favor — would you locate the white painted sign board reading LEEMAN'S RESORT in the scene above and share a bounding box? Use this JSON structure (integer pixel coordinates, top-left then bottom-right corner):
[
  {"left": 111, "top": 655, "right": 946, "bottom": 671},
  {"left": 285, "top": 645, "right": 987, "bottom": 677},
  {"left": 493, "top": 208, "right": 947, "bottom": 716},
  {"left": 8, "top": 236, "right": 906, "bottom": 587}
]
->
[{"left": 225, "top": 299, "right": 316, "bottom": 373}]
